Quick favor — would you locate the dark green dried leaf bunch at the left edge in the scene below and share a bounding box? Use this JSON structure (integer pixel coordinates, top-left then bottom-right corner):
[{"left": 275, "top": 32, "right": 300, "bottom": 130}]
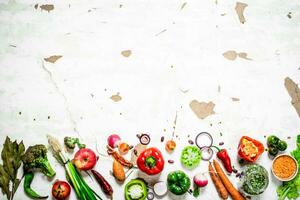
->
[{"left": 0, "top": 137, "right": 25, "bottom": 200}]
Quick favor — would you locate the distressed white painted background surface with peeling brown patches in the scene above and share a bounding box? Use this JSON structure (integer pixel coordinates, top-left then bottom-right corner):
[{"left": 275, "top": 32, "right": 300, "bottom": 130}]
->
[{"left": 0, "top": 0, "right": 300, "bottom": 200}]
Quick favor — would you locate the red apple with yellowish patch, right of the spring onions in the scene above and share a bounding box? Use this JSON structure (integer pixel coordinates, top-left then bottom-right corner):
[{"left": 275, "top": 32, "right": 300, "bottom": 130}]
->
[{"left": 73, "top": 148, "right": 97, "bottom": 171}]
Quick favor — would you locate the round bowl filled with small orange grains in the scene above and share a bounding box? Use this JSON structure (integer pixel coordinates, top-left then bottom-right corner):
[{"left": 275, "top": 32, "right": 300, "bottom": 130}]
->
[{"left": 272, "top": 155, "right": 297, "bottom": 179}]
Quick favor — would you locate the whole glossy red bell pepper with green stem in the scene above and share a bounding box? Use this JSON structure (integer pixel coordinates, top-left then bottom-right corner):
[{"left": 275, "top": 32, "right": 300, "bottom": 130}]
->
[{"left": 137, "top": 147, "right": 165, "bottom": 175}]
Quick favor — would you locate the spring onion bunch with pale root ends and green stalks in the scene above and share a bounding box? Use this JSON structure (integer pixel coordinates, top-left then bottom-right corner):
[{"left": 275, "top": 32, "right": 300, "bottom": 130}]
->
[{"left": 47, "top": 135, "right": 102, "bottom": 200}]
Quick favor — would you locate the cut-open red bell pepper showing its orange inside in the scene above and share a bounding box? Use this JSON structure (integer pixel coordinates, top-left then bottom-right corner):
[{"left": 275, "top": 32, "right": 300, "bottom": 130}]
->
[{"left": 238, "top": 136, "right": 265, "bottom": 163}]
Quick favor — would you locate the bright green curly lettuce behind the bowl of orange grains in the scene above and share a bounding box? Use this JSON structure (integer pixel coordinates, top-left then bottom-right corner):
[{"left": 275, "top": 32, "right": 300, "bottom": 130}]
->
[{"left": 277, "top": 135, "right": 300, "bottom": 200}]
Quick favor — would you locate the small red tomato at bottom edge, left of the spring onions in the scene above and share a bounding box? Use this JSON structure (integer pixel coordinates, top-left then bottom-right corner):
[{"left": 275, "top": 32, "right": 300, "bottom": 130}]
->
[{"left": 52, "top": 181, "right": 71, "bottom": 200}]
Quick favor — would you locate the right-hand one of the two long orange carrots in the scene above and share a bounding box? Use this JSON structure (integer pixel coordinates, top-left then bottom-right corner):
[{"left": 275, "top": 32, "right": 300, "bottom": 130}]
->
[{"left": 213, "top": 160, "right": 246, "bottom": 200}]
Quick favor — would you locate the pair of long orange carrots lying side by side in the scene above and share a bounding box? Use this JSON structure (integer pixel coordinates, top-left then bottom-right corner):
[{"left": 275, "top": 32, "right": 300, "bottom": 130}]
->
[{"left": 208, "top": 160, "right": 246, "bottom": 200}]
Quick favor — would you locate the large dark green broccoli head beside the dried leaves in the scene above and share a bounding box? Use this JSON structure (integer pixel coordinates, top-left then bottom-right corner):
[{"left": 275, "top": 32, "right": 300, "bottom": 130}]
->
[{"left": 22, "top": 144, "right": 55, "bottom": 178}]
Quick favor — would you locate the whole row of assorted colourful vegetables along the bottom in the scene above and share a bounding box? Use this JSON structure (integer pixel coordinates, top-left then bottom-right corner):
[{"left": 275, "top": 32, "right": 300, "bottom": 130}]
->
[{"left": 0, "top": 132, "right": 300, "bottom": 200}]
